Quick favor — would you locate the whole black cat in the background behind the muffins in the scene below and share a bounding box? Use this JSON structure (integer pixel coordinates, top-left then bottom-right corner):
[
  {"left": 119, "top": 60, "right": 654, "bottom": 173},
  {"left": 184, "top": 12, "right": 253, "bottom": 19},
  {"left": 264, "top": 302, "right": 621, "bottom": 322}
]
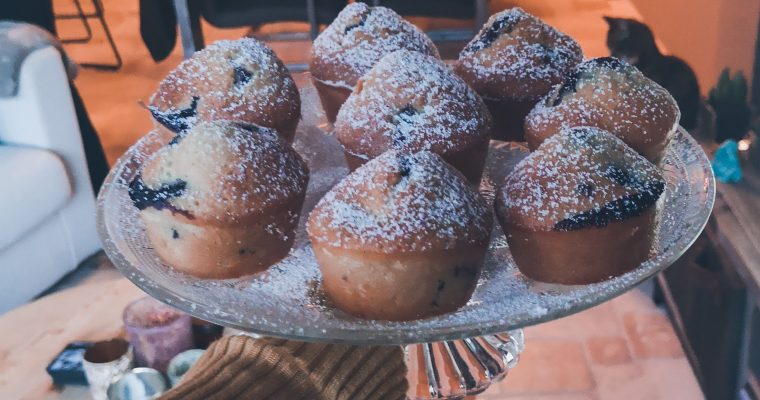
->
[{"left": 604, "top": 17, "right": 701, "bottom": 129}]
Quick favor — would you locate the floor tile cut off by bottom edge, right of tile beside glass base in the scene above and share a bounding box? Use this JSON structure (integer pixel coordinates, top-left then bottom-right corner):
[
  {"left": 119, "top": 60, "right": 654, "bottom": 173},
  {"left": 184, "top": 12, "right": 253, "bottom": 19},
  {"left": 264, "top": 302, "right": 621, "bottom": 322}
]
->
[{"left": 592, "top": 363, "right": 670, "bottom": 400}]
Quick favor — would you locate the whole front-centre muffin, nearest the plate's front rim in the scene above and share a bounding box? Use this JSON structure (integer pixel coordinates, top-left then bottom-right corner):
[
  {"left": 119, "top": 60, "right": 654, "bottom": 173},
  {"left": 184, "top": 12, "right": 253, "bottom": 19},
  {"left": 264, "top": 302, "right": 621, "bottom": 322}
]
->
[{"left": 308, "top": 151, "right": 493, "bottom": 320}]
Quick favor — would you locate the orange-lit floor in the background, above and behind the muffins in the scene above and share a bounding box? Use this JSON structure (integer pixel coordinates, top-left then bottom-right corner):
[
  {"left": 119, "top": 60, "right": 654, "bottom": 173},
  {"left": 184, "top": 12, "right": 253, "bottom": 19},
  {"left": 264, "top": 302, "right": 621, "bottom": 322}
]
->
[{"left": 54, "top": 0, "right": 638, "bottom": 166}]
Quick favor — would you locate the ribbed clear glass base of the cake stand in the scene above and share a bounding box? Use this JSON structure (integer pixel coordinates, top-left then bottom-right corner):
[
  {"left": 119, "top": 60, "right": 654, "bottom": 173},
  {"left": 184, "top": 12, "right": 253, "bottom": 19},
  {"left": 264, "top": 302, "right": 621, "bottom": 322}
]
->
[{"left": 405, "top": 329, "right": 525, "bottom": 400}]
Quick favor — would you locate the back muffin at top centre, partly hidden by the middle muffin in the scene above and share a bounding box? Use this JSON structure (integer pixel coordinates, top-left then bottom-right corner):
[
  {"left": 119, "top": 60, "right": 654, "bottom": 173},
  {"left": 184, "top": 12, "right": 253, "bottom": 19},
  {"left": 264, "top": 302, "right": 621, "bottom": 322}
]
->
[{"left": 309, "top": 2, "right": 440, "bottom": 122}]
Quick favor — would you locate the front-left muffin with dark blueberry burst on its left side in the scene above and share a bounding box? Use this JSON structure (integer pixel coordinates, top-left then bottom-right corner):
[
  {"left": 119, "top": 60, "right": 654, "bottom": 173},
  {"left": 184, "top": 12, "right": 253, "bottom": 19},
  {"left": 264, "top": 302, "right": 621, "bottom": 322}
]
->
[{"left": 129, "top": 121, "right": 309, "bottom": 279}]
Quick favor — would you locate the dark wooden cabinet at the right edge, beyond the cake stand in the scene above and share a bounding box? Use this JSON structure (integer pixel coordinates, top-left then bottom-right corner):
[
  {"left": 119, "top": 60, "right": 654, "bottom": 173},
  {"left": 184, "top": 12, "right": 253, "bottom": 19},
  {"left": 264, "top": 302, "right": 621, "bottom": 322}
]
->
[{"left": 658, "top": 148, "right": 760, "bottom": 400}]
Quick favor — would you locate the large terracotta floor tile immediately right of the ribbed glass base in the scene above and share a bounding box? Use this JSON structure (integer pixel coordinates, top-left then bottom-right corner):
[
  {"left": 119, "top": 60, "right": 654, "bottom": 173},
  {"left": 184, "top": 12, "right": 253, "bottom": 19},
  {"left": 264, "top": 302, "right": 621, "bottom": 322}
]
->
[{"left": 498, "top": 339, "right": 594, "bottom": 395}]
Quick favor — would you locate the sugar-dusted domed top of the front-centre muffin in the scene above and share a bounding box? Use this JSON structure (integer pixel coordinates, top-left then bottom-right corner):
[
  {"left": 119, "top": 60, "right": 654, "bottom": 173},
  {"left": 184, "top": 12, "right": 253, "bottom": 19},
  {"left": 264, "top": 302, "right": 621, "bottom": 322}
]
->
[{"left": 308, "top": 151, "right": 493, "bottom": 253}]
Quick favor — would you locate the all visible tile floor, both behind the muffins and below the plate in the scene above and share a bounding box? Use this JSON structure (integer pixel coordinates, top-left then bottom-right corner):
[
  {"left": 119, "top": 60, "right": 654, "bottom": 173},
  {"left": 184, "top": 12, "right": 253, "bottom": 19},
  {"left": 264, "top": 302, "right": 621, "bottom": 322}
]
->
[{"left": 54, "top": 0, "right": 703, "bottom": 400}]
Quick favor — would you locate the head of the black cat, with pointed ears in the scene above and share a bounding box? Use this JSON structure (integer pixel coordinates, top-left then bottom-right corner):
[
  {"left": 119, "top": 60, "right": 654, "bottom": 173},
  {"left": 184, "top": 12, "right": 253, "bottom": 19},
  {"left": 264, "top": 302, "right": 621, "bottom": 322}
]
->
[{"left": 604, "top": 17, "right": 657, "bottom": 65}]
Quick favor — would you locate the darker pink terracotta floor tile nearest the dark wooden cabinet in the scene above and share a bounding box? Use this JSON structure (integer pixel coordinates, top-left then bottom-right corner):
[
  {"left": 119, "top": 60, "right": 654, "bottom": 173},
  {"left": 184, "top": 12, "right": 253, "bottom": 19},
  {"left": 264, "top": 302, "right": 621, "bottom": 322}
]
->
[{"left": 623, "top": 312, "right": 684, "bottom": 358}]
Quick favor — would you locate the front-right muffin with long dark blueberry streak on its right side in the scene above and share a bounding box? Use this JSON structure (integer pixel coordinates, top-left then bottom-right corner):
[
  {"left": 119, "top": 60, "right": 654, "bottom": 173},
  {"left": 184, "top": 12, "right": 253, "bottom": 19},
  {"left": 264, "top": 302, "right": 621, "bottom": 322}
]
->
[{"left": 496, "top": 127, "right": 665, "bottom": 285}]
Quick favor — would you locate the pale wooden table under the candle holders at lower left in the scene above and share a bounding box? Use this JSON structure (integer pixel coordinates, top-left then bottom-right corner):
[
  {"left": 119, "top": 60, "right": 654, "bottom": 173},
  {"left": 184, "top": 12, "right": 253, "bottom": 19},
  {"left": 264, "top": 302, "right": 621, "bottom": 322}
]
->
[{"left": 0, "top": 276, "right": 145, "bottom": 399}]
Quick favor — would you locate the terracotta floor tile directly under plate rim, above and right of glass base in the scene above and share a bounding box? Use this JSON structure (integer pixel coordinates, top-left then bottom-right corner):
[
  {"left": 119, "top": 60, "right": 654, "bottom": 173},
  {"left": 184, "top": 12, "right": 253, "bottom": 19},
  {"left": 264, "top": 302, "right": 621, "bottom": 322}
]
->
[{"left": 526, "top": 302, "right": 623, "bottom": 340}]
